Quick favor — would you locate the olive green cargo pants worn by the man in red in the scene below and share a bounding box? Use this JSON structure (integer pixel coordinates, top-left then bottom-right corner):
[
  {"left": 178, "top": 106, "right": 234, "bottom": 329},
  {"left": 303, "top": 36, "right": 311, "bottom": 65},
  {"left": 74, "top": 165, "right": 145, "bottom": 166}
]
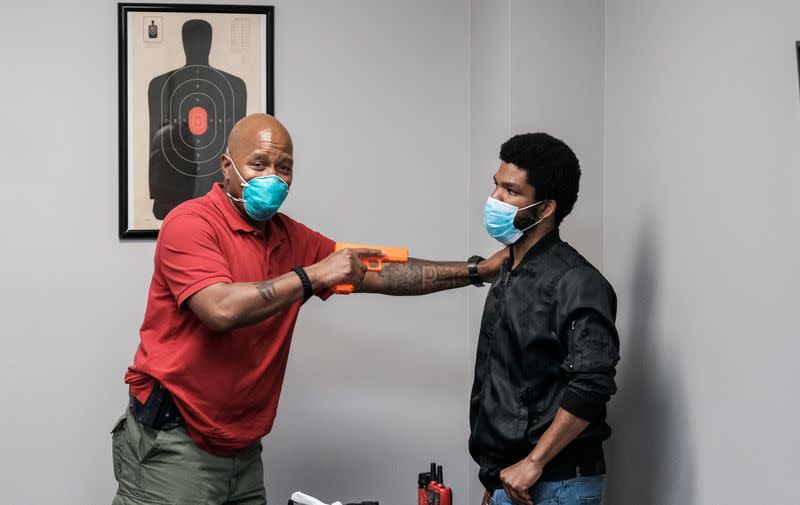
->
[{"left": 111, "top": 412, "right": 267, "bottom": 505}]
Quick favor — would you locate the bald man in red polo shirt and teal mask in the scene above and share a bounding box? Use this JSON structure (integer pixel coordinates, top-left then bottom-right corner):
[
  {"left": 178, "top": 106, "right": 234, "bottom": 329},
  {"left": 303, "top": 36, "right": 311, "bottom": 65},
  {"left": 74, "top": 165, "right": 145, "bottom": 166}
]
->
[{"left": 112, "top": 114, "right": 507, "bottom": 505}]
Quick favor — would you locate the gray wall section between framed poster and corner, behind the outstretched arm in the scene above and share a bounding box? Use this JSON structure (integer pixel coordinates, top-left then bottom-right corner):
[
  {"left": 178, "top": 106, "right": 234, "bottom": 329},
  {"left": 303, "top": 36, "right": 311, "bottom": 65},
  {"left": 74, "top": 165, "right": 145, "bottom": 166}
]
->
[{"left": 264, "top": 0, "right": 470, "bottom": 504}]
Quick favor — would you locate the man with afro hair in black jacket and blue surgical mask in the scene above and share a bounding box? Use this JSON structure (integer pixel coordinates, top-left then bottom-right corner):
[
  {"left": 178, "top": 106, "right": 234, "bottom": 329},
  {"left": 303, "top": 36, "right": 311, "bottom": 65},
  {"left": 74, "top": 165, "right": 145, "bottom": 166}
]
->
[{"left": 469, "top": 133, "right": 619, "bottom": 505}]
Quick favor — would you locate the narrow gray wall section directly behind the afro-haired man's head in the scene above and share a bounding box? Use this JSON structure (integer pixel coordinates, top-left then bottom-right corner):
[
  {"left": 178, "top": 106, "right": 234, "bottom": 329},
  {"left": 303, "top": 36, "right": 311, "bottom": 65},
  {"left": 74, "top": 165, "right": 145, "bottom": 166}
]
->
[{"left": 466, "top": 0, "right": 604, "bottom": 504}]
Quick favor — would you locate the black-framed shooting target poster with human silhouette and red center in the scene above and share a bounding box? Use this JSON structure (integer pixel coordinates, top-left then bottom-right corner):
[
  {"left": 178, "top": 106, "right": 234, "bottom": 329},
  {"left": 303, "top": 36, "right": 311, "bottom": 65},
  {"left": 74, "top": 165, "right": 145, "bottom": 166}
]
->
[{"left": 117, "top": 3, "right": 274, "bottom": 238}]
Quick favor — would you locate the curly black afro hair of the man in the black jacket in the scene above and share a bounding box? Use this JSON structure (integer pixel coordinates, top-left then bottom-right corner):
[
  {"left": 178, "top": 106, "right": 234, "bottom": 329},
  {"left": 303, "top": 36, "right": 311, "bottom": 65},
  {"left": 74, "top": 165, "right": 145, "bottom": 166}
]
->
[{"left": 500, "top": 133, "right": 581, "bottom": 226}]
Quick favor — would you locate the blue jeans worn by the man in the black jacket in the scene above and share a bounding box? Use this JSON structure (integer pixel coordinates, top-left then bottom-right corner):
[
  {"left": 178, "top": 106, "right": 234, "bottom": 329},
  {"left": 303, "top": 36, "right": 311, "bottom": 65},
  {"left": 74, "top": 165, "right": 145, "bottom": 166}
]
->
[{"left": 489, "top": 475, "right": 605, "bottom": 505}]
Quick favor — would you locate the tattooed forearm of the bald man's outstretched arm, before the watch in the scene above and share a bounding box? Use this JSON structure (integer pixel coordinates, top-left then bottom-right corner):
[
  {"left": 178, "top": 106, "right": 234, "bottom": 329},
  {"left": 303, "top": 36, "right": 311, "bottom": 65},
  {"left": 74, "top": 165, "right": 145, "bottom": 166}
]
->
[{"left": 376, "top": 258, "right": 469, "bottom": 296}]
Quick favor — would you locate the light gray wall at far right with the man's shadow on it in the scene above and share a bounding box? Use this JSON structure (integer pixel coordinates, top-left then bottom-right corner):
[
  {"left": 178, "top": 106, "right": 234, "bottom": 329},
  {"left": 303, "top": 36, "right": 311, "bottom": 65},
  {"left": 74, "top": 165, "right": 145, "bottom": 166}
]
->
[{"left": 603, "top": 0, "right": 800, "bottom": 505}]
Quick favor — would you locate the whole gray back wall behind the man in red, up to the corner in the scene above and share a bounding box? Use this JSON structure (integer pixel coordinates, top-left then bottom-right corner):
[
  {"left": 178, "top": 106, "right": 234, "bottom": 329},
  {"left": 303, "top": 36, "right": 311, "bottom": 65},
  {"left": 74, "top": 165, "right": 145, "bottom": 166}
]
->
[{"left": 0, "top": 0, "right": 472, "bottom": 505}]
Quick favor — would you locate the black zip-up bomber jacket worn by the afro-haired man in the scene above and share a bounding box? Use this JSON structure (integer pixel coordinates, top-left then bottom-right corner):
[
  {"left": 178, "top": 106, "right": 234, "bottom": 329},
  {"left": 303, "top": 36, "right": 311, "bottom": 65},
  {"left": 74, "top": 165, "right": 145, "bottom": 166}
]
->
[{"left": 469, "top": 230, "right": 619, "bottom": 489}]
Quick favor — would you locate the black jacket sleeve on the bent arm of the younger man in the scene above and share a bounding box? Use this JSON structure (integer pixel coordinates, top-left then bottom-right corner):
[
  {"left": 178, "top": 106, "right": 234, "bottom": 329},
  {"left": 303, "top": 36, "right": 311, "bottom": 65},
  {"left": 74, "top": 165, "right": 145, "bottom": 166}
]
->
[{"left": 554, "top": 266, "right": 619, "bottom": 422}]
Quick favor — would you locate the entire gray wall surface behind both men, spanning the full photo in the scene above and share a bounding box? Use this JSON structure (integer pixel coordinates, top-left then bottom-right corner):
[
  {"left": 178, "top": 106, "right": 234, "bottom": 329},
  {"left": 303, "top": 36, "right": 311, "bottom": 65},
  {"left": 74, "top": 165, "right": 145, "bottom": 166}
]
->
[{"left": 0, "top": 0, "right": 800, "bottom": 505}]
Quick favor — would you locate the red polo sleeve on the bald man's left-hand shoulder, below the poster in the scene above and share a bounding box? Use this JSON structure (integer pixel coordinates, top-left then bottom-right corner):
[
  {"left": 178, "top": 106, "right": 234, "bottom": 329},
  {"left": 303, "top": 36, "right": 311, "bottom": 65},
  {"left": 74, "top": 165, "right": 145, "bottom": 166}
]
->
[{"left": 155, "top": 214, "right": 232, "bottom": 305}]
